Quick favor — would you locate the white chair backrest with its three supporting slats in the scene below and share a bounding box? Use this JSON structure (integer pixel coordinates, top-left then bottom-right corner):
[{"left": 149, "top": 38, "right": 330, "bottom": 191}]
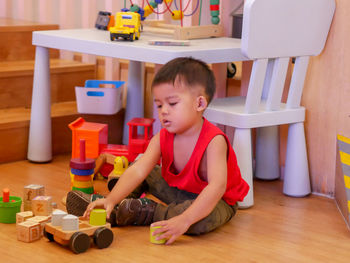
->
[{"left": 242, "top": 0, "right": 335, "bottom": 113}]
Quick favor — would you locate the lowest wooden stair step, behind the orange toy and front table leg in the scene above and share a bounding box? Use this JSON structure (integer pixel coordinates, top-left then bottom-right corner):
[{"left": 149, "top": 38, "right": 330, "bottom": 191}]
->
[{"left": 0, "top": 101, "right": 124, "bottom": 163}]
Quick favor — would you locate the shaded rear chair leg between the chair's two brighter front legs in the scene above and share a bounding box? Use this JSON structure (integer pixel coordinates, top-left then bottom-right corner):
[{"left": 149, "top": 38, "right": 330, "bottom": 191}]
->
[{"left": 255, "top": 126, "right": 280, "bottom": 180}]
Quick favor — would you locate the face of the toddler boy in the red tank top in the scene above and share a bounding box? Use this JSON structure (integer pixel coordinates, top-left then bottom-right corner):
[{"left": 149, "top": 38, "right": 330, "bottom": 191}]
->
[{"left": 153, "top": 83, "right": 203, "bottom": 134}]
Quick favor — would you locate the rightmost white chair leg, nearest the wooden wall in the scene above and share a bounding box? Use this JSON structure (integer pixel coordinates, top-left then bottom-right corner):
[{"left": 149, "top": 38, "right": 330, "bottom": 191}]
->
[{"left": 283, "top": 122, "right": 311, "bottom": 197}]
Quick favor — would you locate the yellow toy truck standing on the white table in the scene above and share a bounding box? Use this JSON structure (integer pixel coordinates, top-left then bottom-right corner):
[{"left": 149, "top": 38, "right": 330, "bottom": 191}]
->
[{"left": 109, "top": 12, "right": 141, "bottom": 41}]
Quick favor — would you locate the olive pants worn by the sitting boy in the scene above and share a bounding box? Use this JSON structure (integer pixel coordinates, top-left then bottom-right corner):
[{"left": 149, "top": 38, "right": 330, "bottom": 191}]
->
[{"left": 129, "top": 165, "right": 238, "bottom": 235}]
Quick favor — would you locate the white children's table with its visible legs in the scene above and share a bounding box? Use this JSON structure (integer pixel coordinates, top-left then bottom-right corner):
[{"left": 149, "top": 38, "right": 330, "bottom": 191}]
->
[{"left": 27, "top": 29, "right": 249, "bottom": 162}]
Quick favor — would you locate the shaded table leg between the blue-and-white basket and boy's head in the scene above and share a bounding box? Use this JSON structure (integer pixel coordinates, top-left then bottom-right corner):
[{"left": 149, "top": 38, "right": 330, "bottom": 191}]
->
[{"left": 123, "top": 60, "right": 145, "bottom": 145}]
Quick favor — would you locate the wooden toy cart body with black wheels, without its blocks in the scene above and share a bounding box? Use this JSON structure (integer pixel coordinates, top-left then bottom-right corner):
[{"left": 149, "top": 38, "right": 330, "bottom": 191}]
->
[{"left": 44, "top": 220, "right": 113, "bottom": 254}]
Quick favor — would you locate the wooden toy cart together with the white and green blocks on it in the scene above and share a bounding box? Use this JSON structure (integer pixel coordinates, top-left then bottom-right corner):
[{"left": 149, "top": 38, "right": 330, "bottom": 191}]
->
[{"left": 44, "top": 211, "right": 114, "bottom": 254}]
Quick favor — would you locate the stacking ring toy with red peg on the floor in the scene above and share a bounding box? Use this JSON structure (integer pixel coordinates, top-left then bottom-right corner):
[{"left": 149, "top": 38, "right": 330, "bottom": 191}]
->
[{"left": 70, "top": 139, "right": 95, "bottom": 194}]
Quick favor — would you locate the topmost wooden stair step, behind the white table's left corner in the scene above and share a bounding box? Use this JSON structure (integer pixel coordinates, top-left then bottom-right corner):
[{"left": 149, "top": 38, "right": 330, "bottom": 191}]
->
[{"left": 0, "top": 18, "right": 59, "bottom": 61}]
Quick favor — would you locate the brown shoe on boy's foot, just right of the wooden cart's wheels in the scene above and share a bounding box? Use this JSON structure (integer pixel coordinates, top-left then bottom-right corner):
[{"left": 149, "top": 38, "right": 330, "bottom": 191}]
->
[{"left": 116, "top": 198, "right": 157, "bottom": 226}]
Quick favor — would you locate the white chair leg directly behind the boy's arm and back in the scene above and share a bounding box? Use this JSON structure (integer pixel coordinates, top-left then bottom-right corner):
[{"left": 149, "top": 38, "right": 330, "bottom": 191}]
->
[{"left": 232, "top": 128, "right": 254, "bottom": 208}]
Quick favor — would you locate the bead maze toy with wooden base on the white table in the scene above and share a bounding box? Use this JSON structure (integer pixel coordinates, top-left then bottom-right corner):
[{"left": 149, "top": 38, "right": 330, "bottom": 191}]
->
[{"left": 122, "top": 0, "right": 223, "bottom": 40}]
